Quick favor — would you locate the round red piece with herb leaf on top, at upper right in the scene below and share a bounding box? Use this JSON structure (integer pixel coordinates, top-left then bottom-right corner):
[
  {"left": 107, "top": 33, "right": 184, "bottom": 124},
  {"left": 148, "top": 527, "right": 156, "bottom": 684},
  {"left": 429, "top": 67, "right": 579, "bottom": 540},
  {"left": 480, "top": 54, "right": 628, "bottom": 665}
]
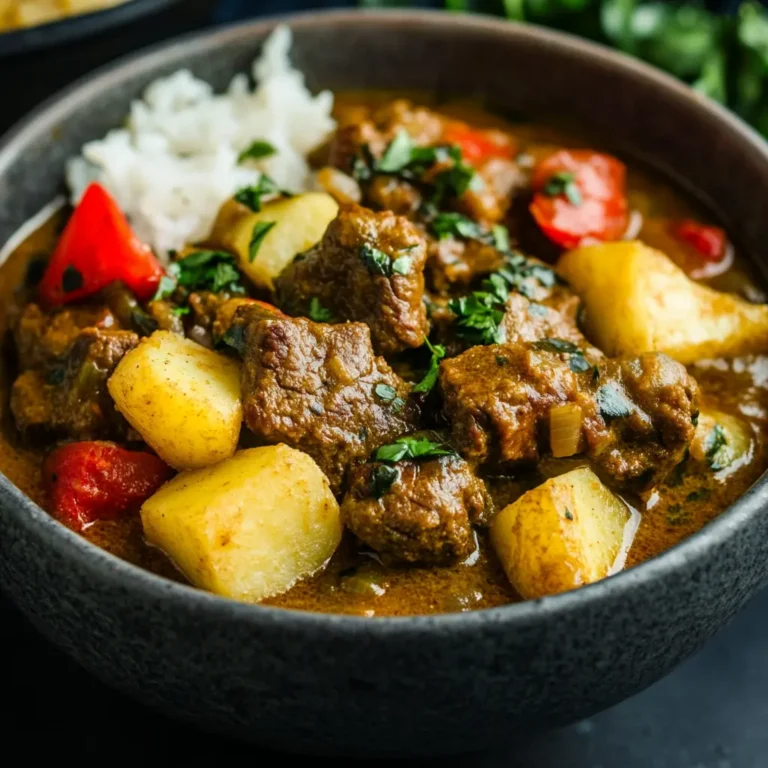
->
[{"left": 531, "top": 149, "right": 628, "bottom": 248}]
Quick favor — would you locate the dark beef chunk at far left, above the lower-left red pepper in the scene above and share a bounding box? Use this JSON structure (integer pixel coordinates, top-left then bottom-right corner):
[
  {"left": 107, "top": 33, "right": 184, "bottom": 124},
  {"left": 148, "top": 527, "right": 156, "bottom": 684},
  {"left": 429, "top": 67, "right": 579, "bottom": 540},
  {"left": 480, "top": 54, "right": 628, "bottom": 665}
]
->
[{"left": 11, "top": 328, "right": 139, "bottom": 440}]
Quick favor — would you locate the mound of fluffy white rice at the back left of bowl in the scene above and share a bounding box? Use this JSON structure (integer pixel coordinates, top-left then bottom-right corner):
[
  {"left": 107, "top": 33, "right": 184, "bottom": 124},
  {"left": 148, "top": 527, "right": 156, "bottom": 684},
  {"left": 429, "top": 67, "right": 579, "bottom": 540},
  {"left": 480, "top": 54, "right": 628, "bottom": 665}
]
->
[{"left": 67, "top": 26, "right": 335, "bottom": 259}]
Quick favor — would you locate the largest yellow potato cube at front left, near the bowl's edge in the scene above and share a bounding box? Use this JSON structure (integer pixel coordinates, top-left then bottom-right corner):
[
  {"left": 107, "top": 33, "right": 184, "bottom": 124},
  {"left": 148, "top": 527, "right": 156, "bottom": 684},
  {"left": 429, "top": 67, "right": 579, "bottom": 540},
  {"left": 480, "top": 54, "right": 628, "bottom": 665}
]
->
[{"left": 141, "top": 445, "right": 342, "bottom": 602}]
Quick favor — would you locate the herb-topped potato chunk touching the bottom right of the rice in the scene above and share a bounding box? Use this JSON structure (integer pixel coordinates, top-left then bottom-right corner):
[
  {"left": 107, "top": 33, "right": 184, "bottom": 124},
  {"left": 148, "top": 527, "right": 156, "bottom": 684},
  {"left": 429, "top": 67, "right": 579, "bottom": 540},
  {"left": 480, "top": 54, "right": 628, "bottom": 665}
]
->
[{"left": 209, "top": 192, "right": 339, "bottom": 290}]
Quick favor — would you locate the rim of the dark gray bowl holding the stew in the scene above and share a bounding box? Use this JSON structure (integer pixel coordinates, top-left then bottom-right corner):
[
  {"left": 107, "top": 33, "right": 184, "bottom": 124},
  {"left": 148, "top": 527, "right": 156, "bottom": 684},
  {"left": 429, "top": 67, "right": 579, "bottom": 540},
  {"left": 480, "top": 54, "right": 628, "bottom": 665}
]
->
[{"left": 0, "top": 9, "right": 768, "bottom": 639}]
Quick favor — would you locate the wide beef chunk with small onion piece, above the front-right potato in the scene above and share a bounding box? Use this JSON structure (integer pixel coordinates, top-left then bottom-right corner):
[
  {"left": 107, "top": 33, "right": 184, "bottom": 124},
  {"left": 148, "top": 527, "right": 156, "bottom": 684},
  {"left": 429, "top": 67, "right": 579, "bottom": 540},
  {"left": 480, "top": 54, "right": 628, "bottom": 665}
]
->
[{"left": 440, "top": 342, "right": 698, "bottom": 488}]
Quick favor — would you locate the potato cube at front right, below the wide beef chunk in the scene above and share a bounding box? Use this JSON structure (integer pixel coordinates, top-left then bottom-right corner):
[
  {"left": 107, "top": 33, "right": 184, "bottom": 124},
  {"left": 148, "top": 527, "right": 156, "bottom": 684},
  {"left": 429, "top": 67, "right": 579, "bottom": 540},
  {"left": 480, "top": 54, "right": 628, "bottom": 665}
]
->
[{"left": 491, "top": 467, "right": 632, "bottom": 600}]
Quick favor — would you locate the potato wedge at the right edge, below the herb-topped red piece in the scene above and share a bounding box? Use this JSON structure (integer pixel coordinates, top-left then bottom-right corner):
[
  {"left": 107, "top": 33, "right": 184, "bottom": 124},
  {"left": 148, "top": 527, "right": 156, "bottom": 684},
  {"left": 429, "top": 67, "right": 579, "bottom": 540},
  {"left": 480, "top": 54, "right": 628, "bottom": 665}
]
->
[{"left": 558, "top": 242, "right": 768, "bottom": 364}]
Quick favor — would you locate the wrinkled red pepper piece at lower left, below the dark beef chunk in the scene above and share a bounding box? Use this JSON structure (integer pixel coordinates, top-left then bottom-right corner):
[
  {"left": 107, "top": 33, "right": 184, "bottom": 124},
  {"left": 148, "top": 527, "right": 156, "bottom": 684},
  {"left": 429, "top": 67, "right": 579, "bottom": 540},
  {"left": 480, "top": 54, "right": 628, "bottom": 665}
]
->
[{"left": 43, "top": 442, "right": 173, "bottom": 531}]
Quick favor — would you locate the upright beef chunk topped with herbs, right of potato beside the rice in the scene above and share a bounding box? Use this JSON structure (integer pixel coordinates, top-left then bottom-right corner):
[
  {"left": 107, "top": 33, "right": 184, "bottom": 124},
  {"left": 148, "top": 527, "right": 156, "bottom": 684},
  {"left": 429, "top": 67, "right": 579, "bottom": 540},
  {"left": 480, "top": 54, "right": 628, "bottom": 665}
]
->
[{"left": 276, "top": 206, "right": 428, "bottom": 354}]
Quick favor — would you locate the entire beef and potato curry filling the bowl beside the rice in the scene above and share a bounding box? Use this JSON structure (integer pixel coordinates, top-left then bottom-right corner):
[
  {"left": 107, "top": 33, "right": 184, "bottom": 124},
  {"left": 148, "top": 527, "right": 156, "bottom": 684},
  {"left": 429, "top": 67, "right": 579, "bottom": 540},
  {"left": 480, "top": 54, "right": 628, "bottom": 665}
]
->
[{"left": 0, "top": 94, "right": 768, "bottom": 616}]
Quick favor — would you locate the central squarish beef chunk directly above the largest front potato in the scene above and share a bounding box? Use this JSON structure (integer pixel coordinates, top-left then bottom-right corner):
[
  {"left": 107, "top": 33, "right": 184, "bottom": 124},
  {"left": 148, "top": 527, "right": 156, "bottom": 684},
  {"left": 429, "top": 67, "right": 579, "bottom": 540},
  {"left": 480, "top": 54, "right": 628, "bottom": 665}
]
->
[{"left": 241, "top": 310, "right": 418, "bottom": 493}]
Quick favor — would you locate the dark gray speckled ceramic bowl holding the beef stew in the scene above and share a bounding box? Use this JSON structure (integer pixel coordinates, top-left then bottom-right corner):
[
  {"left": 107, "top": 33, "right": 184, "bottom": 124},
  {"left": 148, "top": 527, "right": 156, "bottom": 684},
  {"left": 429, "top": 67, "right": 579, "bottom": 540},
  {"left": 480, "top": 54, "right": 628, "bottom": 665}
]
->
[{"left": 0, "top": 12, "right": 768, "bottom": 755}]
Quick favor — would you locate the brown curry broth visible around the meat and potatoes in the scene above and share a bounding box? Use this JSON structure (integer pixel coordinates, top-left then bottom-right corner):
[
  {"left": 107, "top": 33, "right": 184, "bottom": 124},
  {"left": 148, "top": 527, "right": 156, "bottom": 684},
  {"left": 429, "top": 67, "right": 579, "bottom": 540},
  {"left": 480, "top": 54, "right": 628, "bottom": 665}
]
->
[{"left": 0, "top": 93, "right": 768, "bottom": 616}]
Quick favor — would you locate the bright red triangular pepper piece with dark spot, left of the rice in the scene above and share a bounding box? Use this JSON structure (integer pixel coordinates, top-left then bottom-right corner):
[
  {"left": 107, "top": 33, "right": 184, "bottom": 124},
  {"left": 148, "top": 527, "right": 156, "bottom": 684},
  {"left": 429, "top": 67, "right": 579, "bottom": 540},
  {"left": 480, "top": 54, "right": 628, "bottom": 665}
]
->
[{"left": 39, "top": 184, "right": 163, "bottom": 307}]
